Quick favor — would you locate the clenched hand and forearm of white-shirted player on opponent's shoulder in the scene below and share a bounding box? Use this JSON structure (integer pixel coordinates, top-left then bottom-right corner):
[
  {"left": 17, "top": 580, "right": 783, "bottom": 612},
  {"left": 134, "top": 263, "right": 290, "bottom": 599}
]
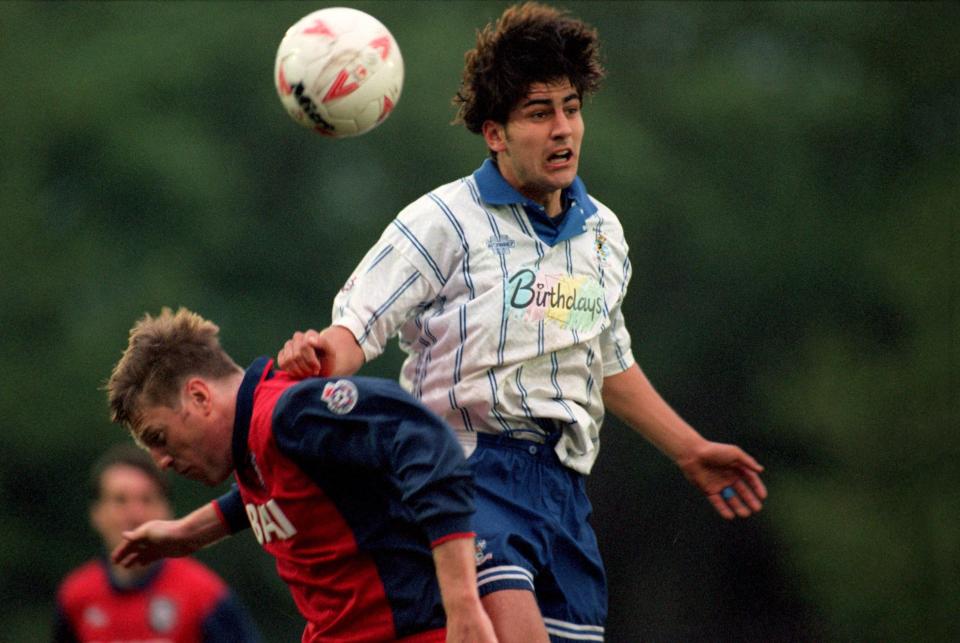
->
[{"left": 277, "top": 326, "right": 364, "bottom": 378}]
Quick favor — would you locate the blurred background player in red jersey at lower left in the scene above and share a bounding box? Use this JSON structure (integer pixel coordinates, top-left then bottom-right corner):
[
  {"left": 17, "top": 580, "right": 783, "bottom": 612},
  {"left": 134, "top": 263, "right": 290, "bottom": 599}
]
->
[{"left": 53, "top": 445, "right": 260, "bottom": 643}]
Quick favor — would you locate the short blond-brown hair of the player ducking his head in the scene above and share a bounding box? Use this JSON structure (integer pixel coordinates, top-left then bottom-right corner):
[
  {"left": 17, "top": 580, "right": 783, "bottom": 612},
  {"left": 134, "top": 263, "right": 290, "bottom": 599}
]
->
[{"left": 104, "top": 307, "right": 242, "bottom": 434}]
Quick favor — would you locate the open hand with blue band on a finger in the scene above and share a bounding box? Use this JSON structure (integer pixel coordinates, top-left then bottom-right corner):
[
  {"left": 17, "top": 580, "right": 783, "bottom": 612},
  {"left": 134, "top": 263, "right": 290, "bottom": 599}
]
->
[{"left": 677, "top": 442, "right": 767, "bottom": 520}]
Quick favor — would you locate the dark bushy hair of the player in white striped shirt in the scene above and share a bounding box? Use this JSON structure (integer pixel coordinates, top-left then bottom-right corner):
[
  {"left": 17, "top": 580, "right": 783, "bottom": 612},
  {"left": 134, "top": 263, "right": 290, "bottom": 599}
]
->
[{"left": 453, "top": 2, "right": 604, "bottom": 134}]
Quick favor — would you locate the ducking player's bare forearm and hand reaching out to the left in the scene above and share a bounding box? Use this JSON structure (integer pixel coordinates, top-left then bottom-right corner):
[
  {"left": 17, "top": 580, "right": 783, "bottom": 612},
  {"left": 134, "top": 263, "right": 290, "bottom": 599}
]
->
[{"left": 111, "top": 502, "right": 230, "bottom": 567}]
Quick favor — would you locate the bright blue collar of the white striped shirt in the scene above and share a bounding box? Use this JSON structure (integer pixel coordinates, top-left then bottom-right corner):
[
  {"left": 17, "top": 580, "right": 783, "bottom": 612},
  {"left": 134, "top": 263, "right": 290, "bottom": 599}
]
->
[{"left": 473, "top": 159, "right": 597, "bottom": 246}]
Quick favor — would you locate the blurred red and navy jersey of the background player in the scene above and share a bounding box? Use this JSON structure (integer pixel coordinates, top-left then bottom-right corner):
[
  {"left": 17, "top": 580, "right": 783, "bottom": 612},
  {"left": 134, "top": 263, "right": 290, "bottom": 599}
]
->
[{"left": 53, "top": 558, "right": 260, "bottom": 643}]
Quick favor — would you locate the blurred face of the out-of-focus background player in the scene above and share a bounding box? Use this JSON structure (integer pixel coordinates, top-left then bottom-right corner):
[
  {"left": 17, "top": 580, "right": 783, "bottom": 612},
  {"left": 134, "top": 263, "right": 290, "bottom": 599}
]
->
[{"left": 90, "top": 464, "right": 170, "bottom": 550}]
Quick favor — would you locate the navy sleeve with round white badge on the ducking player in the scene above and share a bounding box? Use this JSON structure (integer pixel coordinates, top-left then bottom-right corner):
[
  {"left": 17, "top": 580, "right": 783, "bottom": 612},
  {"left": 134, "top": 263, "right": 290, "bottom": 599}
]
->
[{"left": 273, "top": 377, "right": 473, "bottom": 542}]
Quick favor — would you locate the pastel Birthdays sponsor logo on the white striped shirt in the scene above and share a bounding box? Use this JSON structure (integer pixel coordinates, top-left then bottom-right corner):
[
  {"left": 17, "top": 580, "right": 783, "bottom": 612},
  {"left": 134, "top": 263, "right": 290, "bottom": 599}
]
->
[{"left": 504, "top": 268, "right": 603, "bottom": 331}]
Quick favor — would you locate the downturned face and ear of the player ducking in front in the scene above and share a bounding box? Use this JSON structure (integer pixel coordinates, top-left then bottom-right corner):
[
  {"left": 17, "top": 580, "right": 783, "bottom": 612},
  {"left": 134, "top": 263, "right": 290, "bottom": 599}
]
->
[{"left": 138, "top": 384, "right": 233, "bottom": 486}]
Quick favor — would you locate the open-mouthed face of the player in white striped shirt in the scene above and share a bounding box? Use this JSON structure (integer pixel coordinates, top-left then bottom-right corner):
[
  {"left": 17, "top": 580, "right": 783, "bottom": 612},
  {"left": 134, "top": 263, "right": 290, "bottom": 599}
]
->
[{"left": 483, "top": 80, "right": 583, "bottom": 216}]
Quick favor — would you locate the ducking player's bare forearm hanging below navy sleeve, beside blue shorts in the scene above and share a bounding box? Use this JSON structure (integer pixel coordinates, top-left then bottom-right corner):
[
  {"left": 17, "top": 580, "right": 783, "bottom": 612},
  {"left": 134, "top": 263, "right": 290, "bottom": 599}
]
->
[{"left": 433, "top": 538, "right": 497, "bottom": 643}]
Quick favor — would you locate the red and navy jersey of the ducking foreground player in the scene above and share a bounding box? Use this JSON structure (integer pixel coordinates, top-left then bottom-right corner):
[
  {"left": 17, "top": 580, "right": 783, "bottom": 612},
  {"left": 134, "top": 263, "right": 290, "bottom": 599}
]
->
[{"left": 217, "top": 358, "right": 473, "bottom": 641}]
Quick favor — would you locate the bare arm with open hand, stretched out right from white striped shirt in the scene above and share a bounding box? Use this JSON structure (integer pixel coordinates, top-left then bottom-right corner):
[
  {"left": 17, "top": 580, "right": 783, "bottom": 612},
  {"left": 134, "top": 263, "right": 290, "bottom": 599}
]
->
[{"left": 603, "top": 364, "right": 767, "bottom": 520}]
